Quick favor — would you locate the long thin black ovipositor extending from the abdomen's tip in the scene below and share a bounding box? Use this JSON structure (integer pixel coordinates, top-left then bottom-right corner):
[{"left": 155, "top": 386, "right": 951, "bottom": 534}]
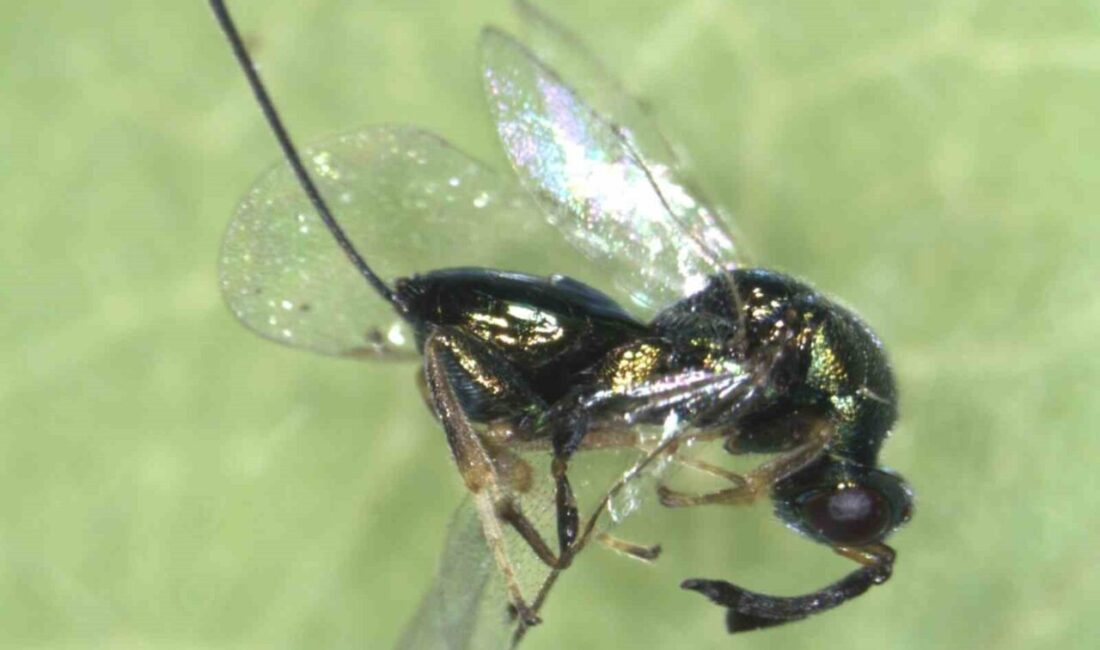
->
[{"left": 210, "top": 0, "right": 400, "bottom": 309}]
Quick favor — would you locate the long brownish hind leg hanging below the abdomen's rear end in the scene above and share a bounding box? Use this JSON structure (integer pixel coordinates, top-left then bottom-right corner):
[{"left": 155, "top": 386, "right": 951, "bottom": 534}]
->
[{"left": 424, "top": 328, "right": 558, "bottom": 625}]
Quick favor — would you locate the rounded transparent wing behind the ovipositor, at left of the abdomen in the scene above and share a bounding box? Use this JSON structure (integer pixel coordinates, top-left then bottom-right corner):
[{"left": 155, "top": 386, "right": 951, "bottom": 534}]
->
[{"left": 220, "top": 126, "right": 620, "bottom": 357}]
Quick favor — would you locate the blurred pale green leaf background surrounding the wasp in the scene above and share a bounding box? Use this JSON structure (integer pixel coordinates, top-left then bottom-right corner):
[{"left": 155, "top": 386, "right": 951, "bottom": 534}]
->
[{"left": 0, "top": 0, "right": 1100, "bottom": 650}]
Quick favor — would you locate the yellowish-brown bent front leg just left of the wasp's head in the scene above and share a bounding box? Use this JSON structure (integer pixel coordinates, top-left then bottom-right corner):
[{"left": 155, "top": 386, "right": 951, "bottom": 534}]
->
[{"left": 657, "top": 429, "right": 829, "bottom": 508}]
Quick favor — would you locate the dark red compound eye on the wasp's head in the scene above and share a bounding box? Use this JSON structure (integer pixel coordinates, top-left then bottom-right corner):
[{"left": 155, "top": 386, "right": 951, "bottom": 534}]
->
[{"left": 802, "top": 486, "right": 890, "bottom": 546}]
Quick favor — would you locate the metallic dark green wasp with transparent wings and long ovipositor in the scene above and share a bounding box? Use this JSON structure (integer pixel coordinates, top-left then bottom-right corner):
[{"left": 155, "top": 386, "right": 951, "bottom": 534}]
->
[{"left": 211, "top": 0, "right": 912, "bottom": 640}]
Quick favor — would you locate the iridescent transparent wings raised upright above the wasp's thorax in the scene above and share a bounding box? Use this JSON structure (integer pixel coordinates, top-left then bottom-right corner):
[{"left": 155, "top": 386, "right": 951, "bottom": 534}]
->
[{"left": 481, "top": 19, "right": 736, "bottom": 312}]
